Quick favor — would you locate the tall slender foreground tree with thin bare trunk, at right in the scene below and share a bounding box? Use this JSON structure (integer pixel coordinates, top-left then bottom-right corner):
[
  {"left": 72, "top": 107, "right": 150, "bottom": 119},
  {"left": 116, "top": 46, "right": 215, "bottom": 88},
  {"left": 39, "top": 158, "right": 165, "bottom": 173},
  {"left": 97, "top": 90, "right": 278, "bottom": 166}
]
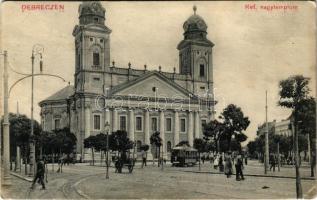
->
[{"left": 278, "top": 75, "right": 310, "bottom": 198}]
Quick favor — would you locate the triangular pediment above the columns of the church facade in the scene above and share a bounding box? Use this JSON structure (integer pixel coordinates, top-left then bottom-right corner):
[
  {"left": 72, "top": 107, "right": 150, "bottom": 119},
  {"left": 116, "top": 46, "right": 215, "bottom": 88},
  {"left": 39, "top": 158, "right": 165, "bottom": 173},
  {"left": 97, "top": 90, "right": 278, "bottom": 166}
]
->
[{"left": 111, "top": 72, "right": 193, "bottom": 99}]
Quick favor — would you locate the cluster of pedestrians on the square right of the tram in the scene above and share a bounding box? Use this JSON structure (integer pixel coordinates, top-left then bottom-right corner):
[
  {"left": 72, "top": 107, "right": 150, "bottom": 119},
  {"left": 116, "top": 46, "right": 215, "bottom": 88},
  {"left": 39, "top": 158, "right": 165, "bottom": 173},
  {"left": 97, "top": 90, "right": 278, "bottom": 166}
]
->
[{"left": 210, "top": 152, "right": 247, "bottom": 181}]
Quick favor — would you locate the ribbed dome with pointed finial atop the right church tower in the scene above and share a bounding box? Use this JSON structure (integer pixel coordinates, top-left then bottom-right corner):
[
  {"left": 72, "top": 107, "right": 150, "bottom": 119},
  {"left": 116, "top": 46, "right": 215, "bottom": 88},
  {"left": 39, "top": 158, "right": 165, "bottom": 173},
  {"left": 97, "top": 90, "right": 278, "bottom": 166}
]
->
[{"left": 183, "top": 6, "right": 207, "bottom": 34}]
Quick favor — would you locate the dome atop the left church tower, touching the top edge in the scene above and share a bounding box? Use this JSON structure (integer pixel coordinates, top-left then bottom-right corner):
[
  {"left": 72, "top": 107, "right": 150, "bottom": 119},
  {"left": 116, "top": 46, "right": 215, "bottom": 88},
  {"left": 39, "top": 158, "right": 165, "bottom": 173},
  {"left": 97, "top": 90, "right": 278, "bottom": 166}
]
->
[{"left": 78, "top": 1, "right": 106, "bottom": 25}]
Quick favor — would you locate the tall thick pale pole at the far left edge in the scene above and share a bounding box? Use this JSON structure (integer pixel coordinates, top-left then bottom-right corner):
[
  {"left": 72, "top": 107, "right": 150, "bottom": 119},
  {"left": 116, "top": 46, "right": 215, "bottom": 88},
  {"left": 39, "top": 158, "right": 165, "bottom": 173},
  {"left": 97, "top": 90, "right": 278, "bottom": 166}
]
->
[{"left": 2, "top": 51, "right": 12, "bottom": 186}]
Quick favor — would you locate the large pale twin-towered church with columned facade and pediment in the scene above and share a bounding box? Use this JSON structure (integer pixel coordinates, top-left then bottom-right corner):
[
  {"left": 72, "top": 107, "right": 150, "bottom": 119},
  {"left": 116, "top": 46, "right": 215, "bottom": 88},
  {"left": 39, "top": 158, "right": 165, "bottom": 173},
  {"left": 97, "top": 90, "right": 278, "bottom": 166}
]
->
[{"left": 39, "top": 2, "right": 215, "bottom": 159}]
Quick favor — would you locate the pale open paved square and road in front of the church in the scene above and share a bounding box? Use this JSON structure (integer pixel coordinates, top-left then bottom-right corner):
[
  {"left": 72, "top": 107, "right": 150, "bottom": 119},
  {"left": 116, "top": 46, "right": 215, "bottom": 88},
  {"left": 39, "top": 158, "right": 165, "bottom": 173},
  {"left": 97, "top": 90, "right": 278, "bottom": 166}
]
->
[{"left": 4, "top": 162, "right": 316, "bottom": 199}]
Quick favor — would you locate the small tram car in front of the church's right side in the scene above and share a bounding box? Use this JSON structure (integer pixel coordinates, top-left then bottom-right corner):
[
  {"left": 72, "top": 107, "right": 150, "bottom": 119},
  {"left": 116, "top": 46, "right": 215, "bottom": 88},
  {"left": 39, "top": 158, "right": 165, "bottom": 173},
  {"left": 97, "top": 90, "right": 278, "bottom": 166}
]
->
[{"left": 171, "top": 146, "right": 199, "bottom": 167}]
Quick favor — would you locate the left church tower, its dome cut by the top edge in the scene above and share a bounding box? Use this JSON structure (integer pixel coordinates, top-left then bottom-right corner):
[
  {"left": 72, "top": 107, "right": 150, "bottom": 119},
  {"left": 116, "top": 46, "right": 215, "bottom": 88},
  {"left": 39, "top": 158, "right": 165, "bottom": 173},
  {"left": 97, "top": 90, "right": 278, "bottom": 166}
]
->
[{"left": 73, "top": 1, "right": 111, "bottom": 93}]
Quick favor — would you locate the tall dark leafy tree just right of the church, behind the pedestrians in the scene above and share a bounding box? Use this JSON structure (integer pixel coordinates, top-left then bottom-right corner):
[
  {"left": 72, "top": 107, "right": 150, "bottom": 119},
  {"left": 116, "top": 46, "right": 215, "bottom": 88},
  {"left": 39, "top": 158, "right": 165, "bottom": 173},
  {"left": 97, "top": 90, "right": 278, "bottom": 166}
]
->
[{"left": 220, "top": 104, "right": 250, "bottom": 151}]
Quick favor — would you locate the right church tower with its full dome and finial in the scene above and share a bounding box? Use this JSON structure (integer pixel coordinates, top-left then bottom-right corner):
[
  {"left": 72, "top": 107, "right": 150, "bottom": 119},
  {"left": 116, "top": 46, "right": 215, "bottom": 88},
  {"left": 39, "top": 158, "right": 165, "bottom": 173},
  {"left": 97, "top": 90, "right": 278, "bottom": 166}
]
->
[{"left": 177, "top": 6, "right": 214, "bottom": 95}]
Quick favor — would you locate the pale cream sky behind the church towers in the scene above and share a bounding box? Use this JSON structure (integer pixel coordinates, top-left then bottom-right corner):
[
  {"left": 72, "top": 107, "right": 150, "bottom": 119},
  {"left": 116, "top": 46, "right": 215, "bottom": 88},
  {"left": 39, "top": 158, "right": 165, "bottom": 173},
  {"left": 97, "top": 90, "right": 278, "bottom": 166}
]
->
[{"left": 0, "top": 1, "right": 316, "bottom": 140}]
